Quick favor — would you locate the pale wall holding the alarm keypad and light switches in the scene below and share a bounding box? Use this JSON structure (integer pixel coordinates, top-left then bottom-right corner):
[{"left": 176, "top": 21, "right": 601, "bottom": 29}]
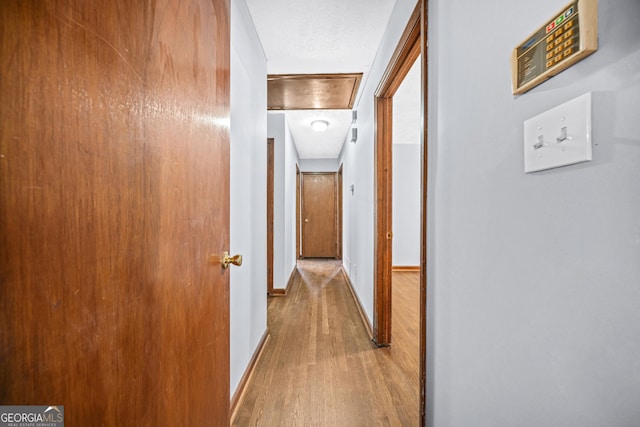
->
[{"left": 427, "top": 0, "right": 640, "bottom": 427}]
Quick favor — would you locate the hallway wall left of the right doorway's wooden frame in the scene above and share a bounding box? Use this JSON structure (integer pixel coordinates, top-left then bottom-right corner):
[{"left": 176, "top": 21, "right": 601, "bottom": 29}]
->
[{"left": 341, "top": 0, "right": 416, "bottom": 328}]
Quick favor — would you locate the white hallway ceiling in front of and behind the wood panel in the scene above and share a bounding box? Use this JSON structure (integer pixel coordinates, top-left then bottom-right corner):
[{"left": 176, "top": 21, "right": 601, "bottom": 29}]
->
[{"left": 246, "top": 0, "right": 395, "bottom": 159}]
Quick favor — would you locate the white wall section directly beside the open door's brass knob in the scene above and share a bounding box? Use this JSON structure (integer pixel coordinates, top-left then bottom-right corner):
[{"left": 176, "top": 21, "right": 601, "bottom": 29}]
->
[{"left": 230, "top": 1, "right": 267, "bottom": 395}]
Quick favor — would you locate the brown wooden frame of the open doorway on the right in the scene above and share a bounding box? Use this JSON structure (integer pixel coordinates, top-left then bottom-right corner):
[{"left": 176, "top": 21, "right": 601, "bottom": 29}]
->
[{"left": 373, "top": 0, "right": 428, "bottom": 426}]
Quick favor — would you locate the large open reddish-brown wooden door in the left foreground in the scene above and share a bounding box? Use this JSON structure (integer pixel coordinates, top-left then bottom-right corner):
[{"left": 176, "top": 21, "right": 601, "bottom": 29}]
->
[{"left": 0, "top": 0, "right": 229, "bottom": 426}]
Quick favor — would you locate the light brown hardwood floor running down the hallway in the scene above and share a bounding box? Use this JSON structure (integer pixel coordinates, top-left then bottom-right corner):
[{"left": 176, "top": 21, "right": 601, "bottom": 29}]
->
[{"left": 232, "top": 260, "right": 419, "bottom": 427}]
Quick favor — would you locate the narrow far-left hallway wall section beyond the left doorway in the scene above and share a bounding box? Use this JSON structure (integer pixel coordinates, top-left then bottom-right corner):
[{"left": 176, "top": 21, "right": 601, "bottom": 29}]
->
[{"left": 267, "top": 113, "right": 298, "bottom": 289}]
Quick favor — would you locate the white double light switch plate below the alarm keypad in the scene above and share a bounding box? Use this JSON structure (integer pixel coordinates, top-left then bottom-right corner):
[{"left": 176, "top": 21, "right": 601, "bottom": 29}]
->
[{"left": 524, "top": 93, "right": 592, "bottom": 173}]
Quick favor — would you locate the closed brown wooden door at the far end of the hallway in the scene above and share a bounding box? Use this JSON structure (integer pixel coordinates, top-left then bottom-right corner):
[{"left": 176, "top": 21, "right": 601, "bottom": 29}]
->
[{"left": 301, "top": 172, "right": 338, "bottom": 258}]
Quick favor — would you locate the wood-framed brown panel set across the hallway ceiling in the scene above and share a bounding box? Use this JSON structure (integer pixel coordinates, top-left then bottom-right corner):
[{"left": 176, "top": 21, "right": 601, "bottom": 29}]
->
[{"left": 267, "top": 73, "right": 362, "bottom": 110}]
